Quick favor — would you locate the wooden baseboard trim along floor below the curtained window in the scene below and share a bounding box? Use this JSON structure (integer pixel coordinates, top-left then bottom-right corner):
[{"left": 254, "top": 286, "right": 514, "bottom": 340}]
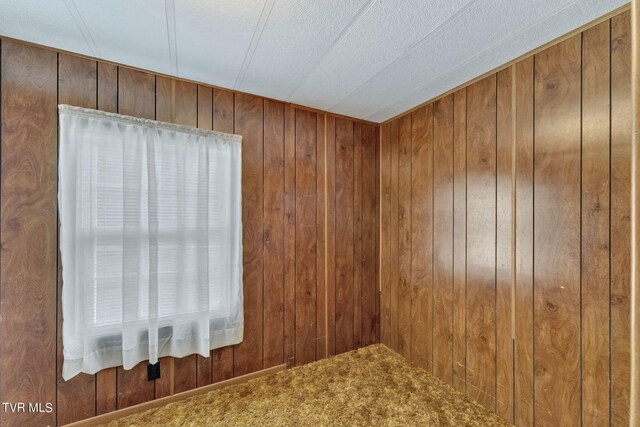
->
[{"left": 66, "top": 364, "right": 287, "bottom": 427}]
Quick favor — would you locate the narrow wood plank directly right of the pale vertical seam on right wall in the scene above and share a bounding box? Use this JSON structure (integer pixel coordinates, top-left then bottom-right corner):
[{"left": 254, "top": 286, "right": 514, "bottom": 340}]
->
[{"left": 514, "top": 58, "right": 534, "bottom": 425}]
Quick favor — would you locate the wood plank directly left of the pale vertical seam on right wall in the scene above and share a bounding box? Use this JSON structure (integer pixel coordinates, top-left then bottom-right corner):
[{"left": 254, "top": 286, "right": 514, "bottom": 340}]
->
[{"left": 496, "top": 67, "right": 514, "bottom": 422}]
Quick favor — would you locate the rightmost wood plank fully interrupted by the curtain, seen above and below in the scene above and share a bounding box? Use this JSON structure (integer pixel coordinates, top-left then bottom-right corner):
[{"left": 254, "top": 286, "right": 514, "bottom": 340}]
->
[{"left": 211, "top": 88, "right": 235, "bottom": 382}]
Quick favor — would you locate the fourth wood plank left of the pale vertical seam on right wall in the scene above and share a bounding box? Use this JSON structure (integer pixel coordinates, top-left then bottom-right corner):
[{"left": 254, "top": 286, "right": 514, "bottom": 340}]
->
[{"left": 432, "top": 95, "right": 454, "bottom": 385}]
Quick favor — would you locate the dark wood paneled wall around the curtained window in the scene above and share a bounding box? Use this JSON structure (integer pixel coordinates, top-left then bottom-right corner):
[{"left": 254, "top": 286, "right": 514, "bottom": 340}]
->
[{"left": 0, "top": 40, "right": 379, "bottom": 426}]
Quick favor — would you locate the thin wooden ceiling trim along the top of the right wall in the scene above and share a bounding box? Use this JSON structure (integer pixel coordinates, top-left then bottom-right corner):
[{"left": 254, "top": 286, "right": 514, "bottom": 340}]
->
[{"left": 380, "top": 3, "right": 631, "bottom": 126}]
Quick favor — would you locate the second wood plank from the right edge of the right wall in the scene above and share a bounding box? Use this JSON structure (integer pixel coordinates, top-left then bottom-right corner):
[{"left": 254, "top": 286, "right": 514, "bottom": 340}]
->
[{"left": 581, "top": 21, "right": 611, "bottom": 425}]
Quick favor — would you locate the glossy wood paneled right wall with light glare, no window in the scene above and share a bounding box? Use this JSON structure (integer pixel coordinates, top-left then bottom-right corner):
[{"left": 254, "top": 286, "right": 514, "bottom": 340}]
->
[{"left": 380, "top": 11, "right": 632, "bottom": 426}]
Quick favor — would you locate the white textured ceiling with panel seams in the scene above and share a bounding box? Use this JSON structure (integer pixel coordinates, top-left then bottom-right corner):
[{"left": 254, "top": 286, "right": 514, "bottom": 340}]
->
[{"left": 0, "top": 0, "right": 628, "bottom": 122}]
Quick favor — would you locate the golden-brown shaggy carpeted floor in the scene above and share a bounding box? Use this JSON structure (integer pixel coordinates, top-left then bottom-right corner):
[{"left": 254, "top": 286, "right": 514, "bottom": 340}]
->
[{"left": 109, "top": 344, "right": 509, "bottom": 427}]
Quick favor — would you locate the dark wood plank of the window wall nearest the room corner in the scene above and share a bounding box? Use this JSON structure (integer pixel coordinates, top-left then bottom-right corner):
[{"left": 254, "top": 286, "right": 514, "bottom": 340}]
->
[{"left": 356, "top": 125, "right": 378, "bottom": 346}]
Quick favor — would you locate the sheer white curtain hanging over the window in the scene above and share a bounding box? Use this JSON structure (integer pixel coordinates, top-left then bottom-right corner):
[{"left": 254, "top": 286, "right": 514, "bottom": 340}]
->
[{"left": 58, "top": 105, "right": 243, "bottom": 380}]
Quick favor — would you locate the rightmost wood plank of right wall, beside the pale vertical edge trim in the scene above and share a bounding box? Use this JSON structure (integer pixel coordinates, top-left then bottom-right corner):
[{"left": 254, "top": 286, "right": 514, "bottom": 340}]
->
[{"left": 610, "top": 12, "right": 632, "bottom": 426}]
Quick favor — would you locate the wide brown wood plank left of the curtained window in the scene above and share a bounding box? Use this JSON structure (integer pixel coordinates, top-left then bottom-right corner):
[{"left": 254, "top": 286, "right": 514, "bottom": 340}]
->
[{"left": 0, "top": 40, "right": 57, "bottom": 426}]
